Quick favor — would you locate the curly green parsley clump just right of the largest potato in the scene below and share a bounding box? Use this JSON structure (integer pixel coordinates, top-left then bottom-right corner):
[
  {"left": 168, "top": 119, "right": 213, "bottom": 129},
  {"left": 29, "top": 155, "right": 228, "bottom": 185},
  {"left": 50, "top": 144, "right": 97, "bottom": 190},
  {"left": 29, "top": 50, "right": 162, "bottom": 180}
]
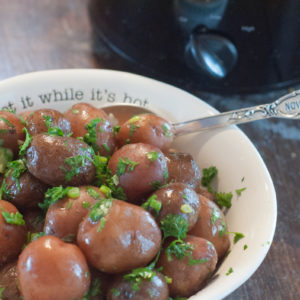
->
[{"left": 161, "top": 214, "right": 189, "bottom": 239}]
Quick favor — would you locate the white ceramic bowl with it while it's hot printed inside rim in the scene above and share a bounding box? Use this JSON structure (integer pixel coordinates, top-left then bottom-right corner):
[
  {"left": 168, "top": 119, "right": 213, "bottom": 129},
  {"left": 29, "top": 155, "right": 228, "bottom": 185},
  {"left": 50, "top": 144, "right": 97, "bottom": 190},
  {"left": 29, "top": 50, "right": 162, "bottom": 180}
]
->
[{"left": 0, "top": 69, "right": 277, "bottom": 300}]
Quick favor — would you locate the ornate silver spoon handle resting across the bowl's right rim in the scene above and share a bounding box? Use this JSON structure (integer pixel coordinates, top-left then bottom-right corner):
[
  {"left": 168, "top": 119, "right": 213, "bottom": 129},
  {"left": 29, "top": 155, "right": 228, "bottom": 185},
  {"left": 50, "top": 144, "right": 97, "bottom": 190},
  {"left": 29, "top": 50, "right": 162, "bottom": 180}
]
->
[{"left": 173, "top": 90, "right": 300, "bottom": 136}]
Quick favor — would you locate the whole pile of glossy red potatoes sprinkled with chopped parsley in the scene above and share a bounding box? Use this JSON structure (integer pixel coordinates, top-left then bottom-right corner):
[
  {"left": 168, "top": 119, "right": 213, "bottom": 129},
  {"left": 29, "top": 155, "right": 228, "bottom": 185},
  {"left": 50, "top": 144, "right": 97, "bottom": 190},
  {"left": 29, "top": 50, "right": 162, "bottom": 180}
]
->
[{"left": 0, "top": 103, "right": 229, "bottom": 300}]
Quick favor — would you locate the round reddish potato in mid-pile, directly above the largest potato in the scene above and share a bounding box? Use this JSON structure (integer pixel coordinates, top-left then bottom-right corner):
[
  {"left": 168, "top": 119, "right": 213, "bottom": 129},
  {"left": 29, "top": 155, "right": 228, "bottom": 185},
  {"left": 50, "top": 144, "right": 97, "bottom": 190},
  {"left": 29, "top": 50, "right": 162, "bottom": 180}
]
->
[{"left": 108, "top": 143, "right": 168, "bottom": 203}]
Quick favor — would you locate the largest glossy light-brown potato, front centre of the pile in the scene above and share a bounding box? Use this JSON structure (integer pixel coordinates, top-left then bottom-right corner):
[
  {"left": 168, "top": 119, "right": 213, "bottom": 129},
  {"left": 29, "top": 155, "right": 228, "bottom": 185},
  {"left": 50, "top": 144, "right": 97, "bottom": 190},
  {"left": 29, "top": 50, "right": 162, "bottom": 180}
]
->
[{"left": 77, "top": 200, "right": 161, "bottom": 273}]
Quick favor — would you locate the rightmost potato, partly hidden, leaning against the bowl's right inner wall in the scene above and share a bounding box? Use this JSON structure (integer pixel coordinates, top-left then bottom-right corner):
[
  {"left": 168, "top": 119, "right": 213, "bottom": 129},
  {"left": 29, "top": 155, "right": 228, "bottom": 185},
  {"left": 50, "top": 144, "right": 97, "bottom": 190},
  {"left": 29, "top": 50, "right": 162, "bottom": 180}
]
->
[{"left": 189, "top": 195, "right": 230, "bottom": 259}]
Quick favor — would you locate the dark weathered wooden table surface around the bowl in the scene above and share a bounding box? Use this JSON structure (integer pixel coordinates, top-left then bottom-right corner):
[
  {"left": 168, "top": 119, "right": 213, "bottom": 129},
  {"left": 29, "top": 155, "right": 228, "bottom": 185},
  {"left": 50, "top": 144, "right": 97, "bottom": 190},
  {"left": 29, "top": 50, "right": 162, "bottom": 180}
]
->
[{"left": 0, "top": 0, "right": 300, "bottom": 300}]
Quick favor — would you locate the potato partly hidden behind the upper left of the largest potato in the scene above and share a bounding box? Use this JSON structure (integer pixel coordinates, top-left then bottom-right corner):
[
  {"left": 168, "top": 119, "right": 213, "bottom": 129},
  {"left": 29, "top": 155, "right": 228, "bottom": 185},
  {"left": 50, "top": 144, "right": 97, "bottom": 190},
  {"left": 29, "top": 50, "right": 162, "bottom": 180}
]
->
[{"left": 43, "top": 186, "right": 105, "bottom": 240}]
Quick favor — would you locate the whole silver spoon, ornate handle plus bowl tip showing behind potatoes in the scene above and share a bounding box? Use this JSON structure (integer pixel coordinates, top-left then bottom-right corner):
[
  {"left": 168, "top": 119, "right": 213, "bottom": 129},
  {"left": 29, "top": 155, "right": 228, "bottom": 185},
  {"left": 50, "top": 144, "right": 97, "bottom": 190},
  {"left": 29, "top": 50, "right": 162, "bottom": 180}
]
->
[{"left": 102, "top": 90, "right": 300, "bottom": 136}]
